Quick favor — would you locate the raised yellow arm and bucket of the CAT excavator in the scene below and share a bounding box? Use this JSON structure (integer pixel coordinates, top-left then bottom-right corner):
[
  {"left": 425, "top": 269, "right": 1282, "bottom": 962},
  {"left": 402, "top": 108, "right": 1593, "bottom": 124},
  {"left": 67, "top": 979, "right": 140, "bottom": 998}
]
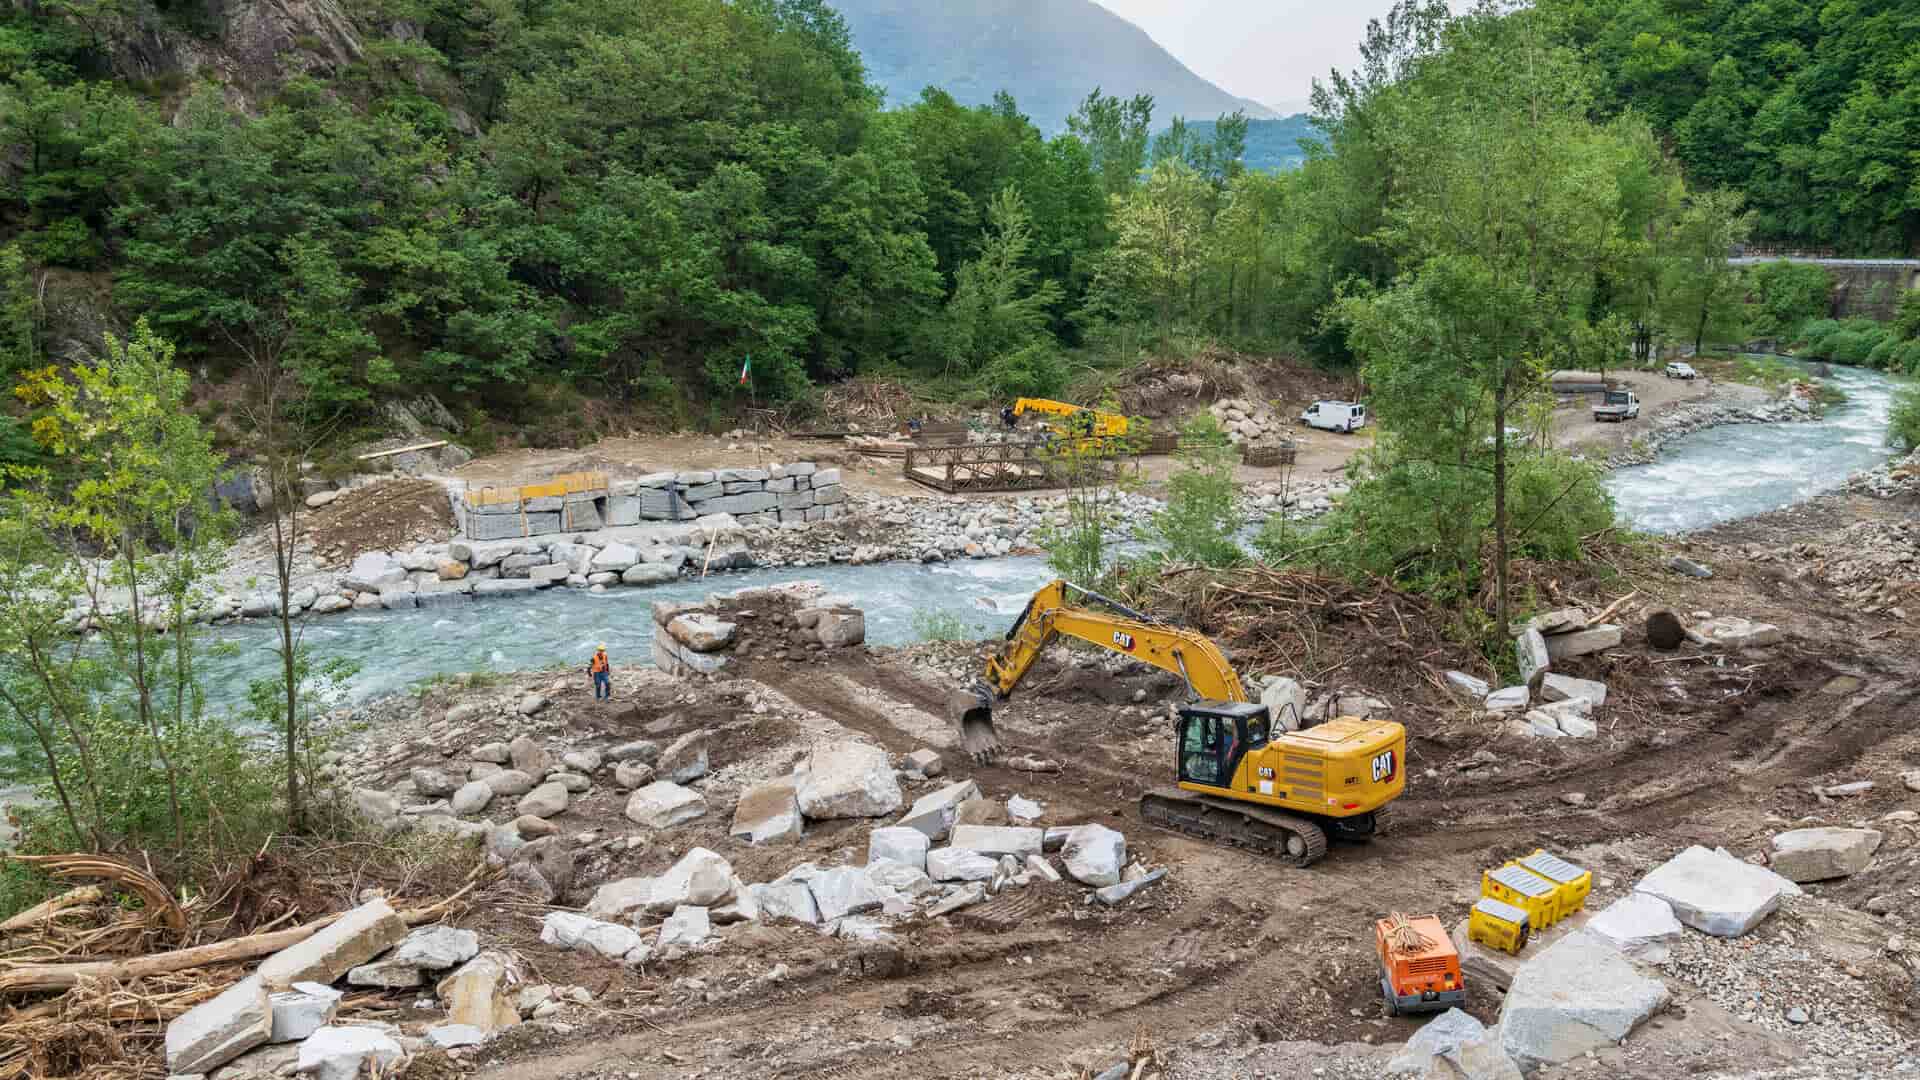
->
[{"left": 950, "top": 580, "right": 1246, "bottom": 761}]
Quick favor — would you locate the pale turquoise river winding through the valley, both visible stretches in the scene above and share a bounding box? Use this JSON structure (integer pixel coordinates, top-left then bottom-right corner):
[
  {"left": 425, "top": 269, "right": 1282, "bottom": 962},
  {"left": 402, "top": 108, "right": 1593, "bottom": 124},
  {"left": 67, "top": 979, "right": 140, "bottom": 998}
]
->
[{"left": 183, "top": 367, "right": 1895, "bottom": 701}]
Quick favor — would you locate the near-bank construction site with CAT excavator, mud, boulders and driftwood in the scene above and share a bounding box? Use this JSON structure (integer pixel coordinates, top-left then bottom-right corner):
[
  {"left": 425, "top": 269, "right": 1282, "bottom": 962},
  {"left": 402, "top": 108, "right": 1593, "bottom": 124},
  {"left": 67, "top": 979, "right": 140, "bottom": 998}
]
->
[{"left": 0, "top": 363, "right": 1920, "bottom": 1080}]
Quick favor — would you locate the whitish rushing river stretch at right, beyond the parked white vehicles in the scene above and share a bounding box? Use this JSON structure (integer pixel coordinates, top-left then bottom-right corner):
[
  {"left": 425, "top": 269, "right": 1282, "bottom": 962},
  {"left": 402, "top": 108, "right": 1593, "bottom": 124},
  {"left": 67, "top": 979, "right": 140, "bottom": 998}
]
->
[{"left": 1607, "top": 359, "right": 1897, "bottom": 534}]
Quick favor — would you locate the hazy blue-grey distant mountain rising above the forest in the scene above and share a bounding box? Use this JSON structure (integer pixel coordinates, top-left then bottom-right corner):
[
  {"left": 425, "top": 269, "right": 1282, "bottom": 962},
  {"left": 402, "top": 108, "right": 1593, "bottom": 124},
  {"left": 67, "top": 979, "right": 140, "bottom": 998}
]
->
[{"left": 829, "top": 0, "right": 1277, "bottom": 133}]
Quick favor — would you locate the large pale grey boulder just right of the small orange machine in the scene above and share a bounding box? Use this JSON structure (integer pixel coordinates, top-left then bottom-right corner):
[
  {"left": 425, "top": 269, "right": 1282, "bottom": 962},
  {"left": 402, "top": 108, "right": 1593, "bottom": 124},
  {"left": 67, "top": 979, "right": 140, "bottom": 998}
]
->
[{"left": 1500, "top": 930, "right": 1668, "bottom": 1068}]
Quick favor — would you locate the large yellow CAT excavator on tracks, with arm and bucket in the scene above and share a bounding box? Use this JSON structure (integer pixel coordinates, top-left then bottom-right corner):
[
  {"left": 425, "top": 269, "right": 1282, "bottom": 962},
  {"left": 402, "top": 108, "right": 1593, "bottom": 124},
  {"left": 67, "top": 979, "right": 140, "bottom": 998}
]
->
[{"left": 948, "top": 580, "right": 1407, "bottom": 867}]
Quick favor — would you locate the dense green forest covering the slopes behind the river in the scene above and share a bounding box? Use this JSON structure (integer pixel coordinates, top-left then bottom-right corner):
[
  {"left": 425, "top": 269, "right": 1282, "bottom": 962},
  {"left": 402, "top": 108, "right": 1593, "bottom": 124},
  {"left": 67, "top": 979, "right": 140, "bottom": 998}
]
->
[{"left": 0, "top": 0, "right": 1920, "bottom": 448}]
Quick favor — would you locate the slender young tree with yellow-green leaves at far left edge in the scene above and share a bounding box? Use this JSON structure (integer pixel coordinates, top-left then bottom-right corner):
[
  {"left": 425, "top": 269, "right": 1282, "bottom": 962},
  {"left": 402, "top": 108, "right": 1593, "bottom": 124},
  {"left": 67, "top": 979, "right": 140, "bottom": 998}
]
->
[{"left": 6, "top": 321, "right": 240, "bottom": 855}]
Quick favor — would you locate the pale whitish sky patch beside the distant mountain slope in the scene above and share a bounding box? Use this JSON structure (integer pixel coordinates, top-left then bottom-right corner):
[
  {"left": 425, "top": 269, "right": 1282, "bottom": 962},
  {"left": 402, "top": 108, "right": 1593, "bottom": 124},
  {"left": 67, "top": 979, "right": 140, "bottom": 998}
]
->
[{"left": 1098, "top": 0, "right": 1392, "bottom": 111}]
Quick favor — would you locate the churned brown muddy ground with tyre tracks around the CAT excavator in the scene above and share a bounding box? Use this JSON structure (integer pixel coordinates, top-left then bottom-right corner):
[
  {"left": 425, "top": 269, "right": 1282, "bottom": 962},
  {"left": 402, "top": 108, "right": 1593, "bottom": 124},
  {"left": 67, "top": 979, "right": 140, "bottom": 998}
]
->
[{"left": 307, "top": 484, "right": 1920, "bottom": 1080}]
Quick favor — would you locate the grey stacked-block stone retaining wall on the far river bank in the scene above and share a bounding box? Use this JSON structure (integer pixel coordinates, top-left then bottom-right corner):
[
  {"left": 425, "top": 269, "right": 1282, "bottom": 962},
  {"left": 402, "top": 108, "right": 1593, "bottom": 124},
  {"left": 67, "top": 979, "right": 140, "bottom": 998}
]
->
[{"left": 459, "top": 461, "right": 847, "bottom": 540}]
